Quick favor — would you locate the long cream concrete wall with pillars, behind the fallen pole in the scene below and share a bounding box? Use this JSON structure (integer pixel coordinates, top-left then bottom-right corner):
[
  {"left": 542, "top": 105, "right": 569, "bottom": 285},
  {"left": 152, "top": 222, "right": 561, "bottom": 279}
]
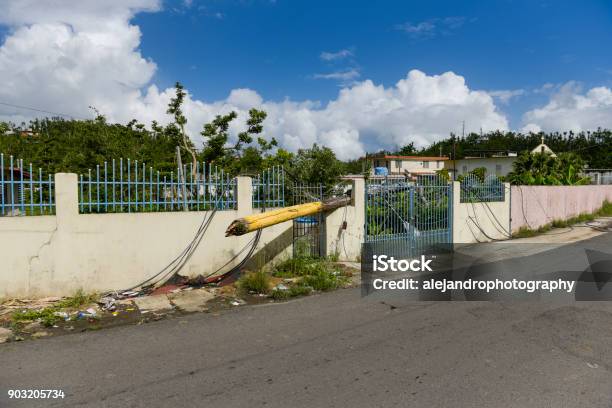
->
[{"left": 0, "top": 174, "right": 364, "bottom": 299}]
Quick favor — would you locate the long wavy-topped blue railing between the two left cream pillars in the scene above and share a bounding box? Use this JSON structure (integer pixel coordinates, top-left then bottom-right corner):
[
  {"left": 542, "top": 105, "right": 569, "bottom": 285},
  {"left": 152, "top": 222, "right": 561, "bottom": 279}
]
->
[{"left": 79, "top": 159, "right": 236, "bottom": 213}]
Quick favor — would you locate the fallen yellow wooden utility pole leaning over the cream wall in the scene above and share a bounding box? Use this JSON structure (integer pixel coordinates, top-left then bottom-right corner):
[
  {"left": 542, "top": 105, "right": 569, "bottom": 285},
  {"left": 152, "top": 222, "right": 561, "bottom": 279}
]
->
[{"left": 225, "top": 197, "right": 351, "bottom": 237}]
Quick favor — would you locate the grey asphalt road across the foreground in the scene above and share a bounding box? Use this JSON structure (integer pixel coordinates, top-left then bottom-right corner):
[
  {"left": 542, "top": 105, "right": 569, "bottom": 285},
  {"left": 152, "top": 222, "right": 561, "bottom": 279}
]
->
[{"left": 0, "top": 234, "right": 612, "bottom": 407}]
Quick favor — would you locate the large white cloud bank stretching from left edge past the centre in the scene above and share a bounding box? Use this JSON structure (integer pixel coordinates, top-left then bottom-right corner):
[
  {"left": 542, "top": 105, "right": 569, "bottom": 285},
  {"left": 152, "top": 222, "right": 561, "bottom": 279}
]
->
[{"left": 0, "top": 0, "right": 508, "bottom": 159}]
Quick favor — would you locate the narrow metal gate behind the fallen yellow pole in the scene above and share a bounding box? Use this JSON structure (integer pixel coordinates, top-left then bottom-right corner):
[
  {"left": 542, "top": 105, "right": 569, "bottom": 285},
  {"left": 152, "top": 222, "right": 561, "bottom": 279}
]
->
[{"left": 292, "top": 184, "right": 323, "bottom": 258}]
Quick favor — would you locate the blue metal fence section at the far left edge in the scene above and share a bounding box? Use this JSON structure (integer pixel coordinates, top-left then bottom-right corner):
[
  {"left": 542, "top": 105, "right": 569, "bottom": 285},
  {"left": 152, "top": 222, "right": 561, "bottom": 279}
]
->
[{"left": 0, "top": 153, "right": 55, "bottom": 216}]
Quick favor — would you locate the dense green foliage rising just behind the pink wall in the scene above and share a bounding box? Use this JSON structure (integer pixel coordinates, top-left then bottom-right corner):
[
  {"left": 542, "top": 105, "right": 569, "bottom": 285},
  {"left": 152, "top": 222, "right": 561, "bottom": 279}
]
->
[{"left": 507, "top": 152, "right": 590, "bottom": 185}]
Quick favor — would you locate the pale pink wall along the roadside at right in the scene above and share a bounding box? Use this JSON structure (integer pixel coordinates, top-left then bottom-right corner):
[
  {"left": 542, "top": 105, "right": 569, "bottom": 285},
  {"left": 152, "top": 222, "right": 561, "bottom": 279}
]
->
[{"left": 511, "top": 185, "right": 612, "bottom": 232}]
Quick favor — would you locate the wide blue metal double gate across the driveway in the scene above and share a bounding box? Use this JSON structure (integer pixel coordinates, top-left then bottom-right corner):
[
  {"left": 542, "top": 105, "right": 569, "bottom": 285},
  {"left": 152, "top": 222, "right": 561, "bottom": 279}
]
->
[{"left": 365, "top": 176, "right": 453, "bottom": 257}]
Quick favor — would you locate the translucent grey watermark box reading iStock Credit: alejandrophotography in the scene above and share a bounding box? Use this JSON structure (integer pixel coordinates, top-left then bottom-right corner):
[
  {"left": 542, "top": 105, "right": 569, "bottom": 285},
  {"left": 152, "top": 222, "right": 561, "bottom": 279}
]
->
[{"left": 361, "top": 241, "right": 612, "bottom": 302}]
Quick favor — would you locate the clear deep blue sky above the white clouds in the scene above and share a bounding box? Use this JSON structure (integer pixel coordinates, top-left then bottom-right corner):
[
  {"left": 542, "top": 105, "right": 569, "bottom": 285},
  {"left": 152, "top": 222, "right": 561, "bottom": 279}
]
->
[{"left": 134, "top": 0, "right": 612, "bottom": 126}]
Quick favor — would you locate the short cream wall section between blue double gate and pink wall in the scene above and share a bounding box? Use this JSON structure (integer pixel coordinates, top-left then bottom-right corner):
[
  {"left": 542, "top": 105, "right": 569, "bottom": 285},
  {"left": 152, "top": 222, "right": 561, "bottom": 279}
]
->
[{"left": 453, "top": 181, "right": 510, "bottom": 244}]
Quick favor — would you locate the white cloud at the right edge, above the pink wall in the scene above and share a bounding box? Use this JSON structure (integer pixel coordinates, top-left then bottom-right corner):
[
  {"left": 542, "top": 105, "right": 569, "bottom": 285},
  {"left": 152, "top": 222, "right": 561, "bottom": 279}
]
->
[{"left": 523, "top": 81, "right": 612, "bottom": 131}]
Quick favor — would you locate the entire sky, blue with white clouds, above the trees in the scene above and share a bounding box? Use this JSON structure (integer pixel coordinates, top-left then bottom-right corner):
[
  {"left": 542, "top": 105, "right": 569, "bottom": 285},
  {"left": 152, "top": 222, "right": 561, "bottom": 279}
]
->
[{"left": 0, "top": 0, "right": 612, "bottom": 159}]
